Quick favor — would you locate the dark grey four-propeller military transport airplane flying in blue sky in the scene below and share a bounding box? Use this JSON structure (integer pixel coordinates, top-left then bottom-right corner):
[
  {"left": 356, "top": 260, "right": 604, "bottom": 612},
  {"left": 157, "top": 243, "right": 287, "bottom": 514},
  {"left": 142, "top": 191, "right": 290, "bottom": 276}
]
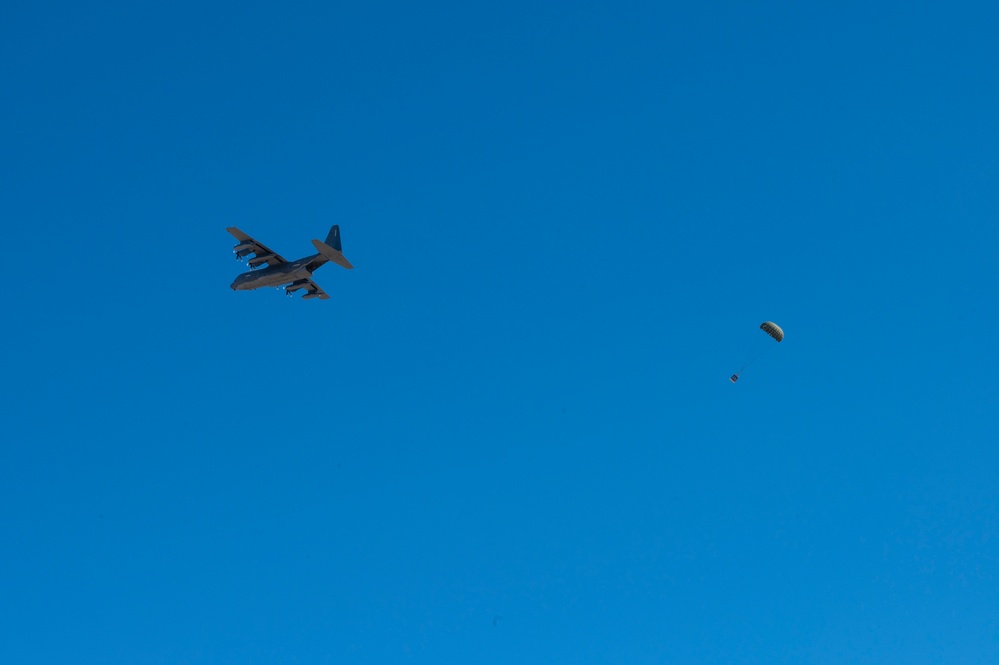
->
[{"left": 226, "top": 225, "right": 354, "bottom": 300}]
